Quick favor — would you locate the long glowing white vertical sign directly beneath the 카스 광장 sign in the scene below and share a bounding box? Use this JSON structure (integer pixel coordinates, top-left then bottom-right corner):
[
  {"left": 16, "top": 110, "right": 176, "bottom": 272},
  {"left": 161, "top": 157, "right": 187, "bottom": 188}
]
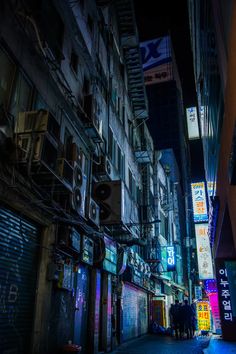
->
[{"left": 195, "top": 223, "right": 214, "bottom": 280}]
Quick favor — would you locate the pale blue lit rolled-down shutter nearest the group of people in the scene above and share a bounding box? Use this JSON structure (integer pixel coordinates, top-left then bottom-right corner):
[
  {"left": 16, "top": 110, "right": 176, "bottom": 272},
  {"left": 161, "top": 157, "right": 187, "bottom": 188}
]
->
[{"left": 123, "top": 283, "right": 148, "bottom": 341}]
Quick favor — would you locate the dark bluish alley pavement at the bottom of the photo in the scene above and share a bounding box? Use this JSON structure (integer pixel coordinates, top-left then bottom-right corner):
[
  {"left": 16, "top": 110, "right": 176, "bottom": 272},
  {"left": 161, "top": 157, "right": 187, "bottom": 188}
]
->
[{"left": 112, "top": 334, "right": 210, "bottom": 354}]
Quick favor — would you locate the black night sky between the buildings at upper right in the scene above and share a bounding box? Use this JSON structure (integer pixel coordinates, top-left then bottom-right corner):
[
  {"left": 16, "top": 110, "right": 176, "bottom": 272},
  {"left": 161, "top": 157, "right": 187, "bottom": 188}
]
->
[{"left": 134, "top": 0, "right": 204, "bottom": 180}]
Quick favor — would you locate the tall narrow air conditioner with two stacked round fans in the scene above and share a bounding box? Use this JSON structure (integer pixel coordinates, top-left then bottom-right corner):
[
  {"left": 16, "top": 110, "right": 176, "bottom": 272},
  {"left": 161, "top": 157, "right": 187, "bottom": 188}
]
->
[{"left": 71, "top": 164, "right": 87, "bottom": 217}]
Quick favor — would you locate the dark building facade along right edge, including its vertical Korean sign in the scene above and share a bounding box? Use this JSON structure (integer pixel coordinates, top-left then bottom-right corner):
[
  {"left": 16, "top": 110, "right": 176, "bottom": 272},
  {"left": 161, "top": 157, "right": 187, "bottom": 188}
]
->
[{"left": 188, "top": 1, "right": 236, "bottom": 340}]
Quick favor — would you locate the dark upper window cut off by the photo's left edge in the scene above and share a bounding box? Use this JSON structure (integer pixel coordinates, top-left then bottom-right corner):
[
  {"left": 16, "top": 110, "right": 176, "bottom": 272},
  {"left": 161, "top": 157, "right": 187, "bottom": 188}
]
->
[{"left": 0, "top": 49, "right": 15, "bottom": 107}]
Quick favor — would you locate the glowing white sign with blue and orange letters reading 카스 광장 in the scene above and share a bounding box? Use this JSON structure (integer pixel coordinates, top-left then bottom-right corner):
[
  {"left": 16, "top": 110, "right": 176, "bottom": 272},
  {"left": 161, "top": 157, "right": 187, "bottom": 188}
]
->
[{"left": 191, "top": 182, "right": 208, "bottom": 222}]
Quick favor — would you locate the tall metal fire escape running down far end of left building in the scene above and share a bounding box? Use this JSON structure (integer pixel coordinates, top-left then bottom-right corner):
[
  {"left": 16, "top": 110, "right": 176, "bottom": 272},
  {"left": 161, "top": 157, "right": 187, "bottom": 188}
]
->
[{"left": 116, "top": 0, "right": 153, "bottom": 252}]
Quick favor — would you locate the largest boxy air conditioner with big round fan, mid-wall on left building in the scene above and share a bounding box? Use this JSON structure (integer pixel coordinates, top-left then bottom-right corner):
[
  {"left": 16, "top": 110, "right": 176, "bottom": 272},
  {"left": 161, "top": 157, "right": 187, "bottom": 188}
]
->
[{"left": 93, "top": 180, "right": 125, "bottom": 225}]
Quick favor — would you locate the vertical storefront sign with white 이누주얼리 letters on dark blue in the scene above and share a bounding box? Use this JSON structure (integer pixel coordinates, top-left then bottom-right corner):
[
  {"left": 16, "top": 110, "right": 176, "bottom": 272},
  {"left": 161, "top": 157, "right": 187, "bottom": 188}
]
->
[{"left": 216, "top": 260, "right": 234, "bottom": 323}]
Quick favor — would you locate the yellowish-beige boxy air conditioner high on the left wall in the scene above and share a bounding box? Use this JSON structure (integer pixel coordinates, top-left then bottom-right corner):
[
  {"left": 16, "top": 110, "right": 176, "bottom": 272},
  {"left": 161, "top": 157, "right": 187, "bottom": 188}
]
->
[{"left": 15, "top": 109, "right": 60, "bottom": 140}]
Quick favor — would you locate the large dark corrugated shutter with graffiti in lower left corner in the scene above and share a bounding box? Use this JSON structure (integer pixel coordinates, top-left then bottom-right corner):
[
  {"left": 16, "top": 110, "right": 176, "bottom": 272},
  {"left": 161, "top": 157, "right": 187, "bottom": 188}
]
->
[{"left": 0, "top": 208, "right": 39, "bottom": 354}]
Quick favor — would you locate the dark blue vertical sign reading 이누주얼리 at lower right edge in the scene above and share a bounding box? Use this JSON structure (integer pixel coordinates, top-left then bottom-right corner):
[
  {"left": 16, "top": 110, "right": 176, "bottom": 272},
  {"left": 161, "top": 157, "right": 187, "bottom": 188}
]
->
[{"left": 215, "top": 259, "right": 236, "bottom": 340}]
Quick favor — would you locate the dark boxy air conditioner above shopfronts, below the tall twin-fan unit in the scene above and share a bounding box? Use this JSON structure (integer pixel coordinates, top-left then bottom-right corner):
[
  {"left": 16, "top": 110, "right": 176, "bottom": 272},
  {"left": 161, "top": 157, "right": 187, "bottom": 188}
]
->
[{"left": 58, "top": 226, "right": 81, "bottom": 253}]
